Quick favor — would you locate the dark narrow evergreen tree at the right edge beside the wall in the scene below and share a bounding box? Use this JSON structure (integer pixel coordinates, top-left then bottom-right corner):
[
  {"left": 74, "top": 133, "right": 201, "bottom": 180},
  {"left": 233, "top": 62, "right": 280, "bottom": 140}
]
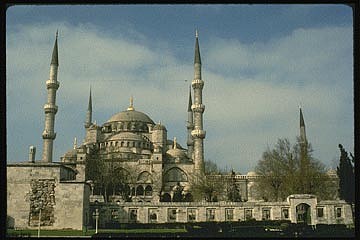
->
[{"left": 337, "top": 144, "right": 355, "bottom": 203}]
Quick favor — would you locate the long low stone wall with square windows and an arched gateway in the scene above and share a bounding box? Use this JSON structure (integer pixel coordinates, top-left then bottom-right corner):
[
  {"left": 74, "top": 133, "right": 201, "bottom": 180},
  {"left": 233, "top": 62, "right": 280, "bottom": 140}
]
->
[{"left": 90, "top": 194, "right": 353, "bottom": 227}]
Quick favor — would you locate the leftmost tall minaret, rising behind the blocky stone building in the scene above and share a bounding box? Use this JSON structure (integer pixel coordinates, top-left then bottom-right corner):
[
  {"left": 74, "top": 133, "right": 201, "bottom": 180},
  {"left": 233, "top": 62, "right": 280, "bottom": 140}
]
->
[{"left": 42, "top": 31, "right": 59, "bottom": 162}]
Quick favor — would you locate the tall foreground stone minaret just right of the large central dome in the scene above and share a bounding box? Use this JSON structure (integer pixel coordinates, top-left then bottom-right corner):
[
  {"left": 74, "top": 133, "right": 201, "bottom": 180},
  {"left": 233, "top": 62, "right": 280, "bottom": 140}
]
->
[{"left": 191, "top": 31, "right": 206, "bottom": 173}]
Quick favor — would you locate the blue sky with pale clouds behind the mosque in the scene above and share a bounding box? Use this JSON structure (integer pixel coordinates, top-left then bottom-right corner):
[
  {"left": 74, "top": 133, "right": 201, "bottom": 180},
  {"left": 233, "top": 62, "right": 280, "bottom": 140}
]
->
[{"left": 6, "top": 5, "right": 354, "bottom": 173}]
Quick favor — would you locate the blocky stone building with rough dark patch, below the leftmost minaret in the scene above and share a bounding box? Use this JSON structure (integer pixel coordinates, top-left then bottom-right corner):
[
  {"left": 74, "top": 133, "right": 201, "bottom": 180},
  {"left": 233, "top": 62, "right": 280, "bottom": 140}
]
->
[{"left": 7, "top": 162, "right": 90, "bottom": 229}]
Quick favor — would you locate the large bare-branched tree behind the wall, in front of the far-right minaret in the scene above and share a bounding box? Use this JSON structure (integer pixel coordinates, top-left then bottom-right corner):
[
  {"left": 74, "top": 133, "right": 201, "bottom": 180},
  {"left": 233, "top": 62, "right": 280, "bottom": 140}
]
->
[{"left": 255, "top": 138, "right": 330, "bottom": 201}]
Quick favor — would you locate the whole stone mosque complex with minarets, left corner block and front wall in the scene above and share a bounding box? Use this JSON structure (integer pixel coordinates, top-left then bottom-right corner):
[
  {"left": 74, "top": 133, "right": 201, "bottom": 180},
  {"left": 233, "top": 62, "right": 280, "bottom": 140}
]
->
[{"left": 7, "top": 33, "right": 352, "bottom": 229}]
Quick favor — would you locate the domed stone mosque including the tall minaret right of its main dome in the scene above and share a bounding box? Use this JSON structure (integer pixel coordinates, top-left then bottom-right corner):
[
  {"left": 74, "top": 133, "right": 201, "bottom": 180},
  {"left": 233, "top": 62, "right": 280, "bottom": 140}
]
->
[{"left": 61, "top": 29, "right": 206, "bottom": 202}]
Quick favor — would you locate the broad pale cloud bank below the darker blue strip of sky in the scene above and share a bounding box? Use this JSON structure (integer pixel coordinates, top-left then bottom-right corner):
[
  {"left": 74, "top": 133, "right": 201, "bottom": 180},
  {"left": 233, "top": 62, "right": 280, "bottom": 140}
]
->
[{"left": 7, "top": 22, "right": 353, "bottom": 173}]
